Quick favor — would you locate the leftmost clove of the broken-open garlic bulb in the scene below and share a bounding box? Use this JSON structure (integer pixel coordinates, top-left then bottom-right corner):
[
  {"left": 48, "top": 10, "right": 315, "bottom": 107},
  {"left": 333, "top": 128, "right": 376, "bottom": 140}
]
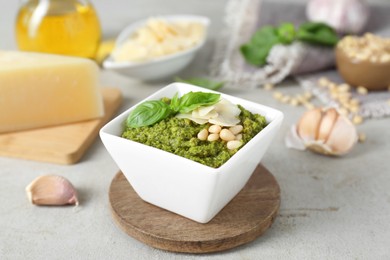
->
[{"left": 297, "top": 108, "right": 322, "bottom": 142}]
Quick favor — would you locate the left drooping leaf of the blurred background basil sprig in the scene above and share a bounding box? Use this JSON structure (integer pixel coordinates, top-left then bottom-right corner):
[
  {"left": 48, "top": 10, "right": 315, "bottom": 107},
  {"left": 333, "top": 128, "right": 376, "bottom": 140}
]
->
[{"left": 240, "top": 26, "right": 281, "bottom": 66}]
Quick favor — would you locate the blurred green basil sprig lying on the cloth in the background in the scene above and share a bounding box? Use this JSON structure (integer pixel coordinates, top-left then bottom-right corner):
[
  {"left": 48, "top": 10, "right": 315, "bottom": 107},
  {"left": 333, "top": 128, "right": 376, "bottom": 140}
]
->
[{"left": 240, "top": 22, "right": 338, "bottom": 66}]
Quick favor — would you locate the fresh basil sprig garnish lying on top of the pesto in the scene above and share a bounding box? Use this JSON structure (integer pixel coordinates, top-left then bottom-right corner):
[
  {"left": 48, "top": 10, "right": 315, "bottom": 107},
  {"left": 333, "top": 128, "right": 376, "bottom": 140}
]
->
[{"left": 126, "top": 92, "right": 221, "bottom": 128}]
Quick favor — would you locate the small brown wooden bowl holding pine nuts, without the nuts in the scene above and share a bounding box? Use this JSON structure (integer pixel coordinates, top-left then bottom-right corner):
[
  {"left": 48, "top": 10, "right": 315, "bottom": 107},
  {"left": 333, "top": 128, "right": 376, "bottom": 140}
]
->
[{"left": 336, "top": 46, "right": 390, "bottom": 90}]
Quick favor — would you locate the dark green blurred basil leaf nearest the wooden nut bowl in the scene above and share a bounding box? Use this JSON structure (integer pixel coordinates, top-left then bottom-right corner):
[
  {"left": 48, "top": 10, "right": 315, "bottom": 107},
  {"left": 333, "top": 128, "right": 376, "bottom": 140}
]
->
[{"left": 297, "top": 22, "right": 338, "bottom": 46}]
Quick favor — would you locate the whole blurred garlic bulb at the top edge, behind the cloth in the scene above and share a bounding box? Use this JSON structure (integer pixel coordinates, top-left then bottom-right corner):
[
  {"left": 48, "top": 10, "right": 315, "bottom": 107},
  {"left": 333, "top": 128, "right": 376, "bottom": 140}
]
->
[{"left": 306, "top": 0, "right": 369, "bottom": 34}]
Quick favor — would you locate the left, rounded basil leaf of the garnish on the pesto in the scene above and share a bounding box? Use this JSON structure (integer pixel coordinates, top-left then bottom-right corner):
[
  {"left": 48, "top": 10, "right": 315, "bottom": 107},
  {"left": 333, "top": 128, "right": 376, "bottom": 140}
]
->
[{"left": 126, "top": 100, "right": 172, "bottom": 128}]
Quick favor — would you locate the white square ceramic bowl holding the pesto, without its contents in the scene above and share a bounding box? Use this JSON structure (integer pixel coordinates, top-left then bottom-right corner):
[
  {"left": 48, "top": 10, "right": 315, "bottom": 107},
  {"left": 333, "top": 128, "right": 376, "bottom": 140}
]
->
[{"left": 100, "top": 83, "right": 283, "bottom": 223}]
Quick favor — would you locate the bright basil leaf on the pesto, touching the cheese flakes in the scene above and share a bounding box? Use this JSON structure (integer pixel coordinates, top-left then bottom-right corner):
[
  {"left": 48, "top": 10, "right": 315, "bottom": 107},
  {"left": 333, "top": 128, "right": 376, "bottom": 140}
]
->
[{"left": 179, "top": 92, "right": 221, "bottom": 113}]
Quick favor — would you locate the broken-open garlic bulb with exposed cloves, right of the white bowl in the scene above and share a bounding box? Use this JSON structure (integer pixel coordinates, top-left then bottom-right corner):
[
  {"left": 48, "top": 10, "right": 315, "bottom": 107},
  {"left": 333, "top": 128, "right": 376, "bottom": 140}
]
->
[{"left": 296, "top": 108, "right": 358, "bottom": 155}]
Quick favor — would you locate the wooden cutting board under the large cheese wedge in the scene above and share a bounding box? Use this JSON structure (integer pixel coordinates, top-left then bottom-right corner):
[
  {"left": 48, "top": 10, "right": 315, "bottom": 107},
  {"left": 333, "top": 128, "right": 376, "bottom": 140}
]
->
[{"left": 0, "top": 88, "right": 122, "bottom": 164}]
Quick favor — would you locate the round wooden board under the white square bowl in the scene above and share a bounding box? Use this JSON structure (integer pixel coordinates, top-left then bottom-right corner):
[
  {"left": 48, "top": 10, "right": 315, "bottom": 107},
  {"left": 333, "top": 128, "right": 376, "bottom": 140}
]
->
[{"left": 109, "top": 165, "right": 280, "bottom": 253}]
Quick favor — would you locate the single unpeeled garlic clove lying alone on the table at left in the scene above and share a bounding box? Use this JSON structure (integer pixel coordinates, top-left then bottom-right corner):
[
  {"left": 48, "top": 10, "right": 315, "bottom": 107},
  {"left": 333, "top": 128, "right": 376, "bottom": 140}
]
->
[{"left": 26, "top": 175, "right": 79, "bottom": 206}]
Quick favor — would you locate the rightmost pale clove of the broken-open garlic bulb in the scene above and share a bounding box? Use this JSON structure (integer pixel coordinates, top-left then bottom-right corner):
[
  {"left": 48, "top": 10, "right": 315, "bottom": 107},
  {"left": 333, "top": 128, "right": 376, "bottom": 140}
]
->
[{"left": 326, "top": 116, "right": 358, "bottom": 155}]
